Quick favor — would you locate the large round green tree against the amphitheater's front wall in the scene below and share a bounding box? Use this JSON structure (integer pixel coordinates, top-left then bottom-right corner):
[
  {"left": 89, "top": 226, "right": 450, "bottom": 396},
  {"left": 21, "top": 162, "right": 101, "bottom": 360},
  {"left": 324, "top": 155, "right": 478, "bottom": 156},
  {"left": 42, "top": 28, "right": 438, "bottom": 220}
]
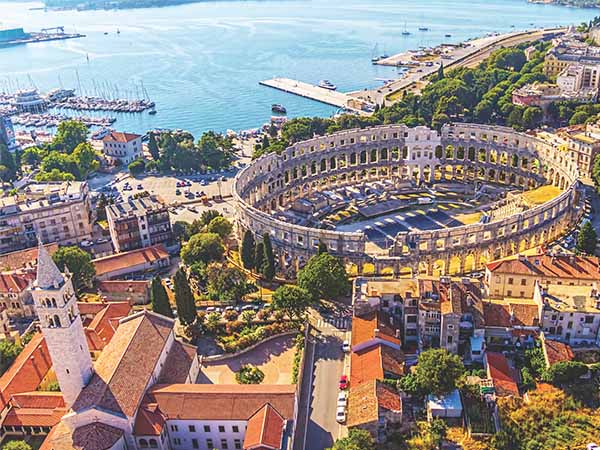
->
[{"left": 298, "top": 253, "right": 350, "bottom": 300}]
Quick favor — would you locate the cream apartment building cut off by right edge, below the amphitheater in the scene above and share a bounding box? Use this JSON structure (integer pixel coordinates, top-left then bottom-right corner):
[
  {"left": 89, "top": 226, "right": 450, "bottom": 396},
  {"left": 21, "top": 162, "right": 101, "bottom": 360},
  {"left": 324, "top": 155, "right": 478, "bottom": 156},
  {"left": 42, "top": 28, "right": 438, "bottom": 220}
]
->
[{"left": 533, "top": 283, "right": 600, "bottom": 345}]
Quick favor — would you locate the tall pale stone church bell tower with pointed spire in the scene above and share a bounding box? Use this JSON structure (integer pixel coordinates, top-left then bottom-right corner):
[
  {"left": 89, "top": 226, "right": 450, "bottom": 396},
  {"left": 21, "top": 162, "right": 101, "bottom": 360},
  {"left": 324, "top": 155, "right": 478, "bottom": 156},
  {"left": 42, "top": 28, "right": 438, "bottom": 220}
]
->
[{"left": 31, "top": 242, "right": 93, "bottom": 407}]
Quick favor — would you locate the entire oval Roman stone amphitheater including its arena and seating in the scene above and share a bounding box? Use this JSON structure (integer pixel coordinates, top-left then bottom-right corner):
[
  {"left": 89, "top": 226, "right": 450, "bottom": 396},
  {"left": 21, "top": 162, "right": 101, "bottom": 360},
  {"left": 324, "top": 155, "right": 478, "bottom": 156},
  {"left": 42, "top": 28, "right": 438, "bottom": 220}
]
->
[{"left": 233, "top": 124, "right": 582, "bottom": 276}]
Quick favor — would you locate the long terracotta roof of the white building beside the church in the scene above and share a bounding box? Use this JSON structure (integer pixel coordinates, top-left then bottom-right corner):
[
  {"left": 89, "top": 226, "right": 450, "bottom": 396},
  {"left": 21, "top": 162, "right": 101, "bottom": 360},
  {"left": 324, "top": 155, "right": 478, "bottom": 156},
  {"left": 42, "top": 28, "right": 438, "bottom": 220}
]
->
[{"left": 148, "top": 384, "right": 296, "bottom": 420}]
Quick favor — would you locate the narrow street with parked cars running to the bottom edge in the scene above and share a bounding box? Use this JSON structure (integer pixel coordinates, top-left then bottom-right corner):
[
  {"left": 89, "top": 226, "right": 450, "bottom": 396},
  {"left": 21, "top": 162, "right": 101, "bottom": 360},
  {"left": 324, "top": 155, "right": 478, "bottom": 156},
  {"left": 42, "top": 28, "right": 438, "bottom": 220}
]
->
[{"left": 295, "top": 312, "right": 350, "bottom": 450}]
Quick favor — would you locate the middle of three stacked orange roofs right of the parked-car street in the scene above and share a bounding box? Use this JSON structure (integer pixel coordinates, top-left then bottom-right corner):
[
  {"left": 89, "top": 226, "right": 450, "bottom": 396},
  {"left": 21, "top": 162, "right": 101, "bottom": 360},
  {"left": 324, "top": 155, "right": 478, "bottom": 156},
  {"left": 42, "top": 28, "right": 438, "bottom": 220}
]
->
[{"left": 350, "top": 344, "right": 404, "bottom": 386}]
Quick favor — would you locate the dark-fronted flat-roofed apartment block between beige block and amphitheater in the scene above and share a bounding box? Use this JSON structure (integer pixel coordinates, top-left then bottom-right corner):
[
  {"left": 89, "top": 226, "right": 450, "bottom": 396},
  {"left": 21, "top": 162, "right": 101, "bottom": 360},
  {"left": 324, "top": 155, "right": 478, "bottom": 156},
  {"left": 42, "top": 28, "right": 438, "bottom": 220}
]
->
[{"left": 106, "top": 195, "right": 173, "bottom": 253}]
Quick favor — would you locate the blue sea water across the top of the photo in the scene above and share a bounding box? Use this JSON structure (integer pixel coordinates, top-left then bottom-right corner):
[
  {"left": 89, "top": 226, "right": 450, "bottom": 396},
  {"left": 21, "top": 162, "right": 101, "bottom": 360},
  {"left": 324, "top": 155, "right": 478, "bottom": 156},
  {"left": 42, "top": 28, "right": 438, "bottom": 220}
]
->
[{"left": 0, "top": 0, "right": 600, "bottom": 135}]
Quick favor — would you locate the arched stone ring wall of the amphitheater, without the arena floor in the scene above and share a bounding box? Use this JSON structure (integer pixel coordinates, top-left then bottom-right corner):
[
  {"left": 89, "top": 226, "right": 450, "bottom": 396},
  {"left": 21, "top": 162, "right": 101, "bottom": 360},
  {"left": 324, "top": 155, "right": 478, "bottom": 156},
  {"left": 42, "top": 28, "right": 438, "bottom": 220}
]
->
[{"left": 233, "top": 124, "right": 582, "bottom": 274}]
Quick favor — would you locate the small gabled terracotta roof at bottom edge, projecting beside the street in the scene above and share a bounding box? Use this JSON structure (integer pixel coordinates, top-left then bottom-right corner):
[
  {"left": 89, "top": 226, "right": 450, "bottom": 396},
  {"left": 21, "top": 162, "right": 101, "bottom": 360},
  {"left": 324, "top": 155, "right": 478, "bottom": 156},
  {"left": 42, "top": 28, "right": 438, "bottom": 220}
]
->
[{"left": 244, "top": 403, "right": 285, "bottom": 450}]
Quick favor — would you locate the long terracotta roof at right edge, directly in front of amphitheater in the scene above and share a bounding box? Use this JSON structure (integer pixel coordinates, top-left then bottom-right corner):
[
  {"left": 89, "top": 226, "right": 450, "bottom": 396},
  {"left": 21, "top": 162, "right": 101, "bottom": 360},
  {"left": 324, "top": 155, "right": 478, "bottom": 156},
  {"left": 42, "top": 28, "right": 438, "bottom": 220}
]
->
[{"left": 486, "top": 254, "right": 600, "bottom": 280}]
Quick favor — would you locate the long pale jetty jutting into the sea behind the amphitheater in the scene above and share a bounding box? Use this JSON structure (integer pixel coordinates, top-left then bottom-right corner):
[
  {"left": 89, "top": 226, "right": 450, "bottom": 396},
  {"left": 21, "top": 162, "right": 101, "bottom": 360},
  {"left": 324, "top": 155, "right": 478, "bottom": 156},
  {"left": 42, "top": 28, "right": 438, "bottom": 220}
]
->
[{"left": 259, "top": 78, "right": 373, "bottom": 115}]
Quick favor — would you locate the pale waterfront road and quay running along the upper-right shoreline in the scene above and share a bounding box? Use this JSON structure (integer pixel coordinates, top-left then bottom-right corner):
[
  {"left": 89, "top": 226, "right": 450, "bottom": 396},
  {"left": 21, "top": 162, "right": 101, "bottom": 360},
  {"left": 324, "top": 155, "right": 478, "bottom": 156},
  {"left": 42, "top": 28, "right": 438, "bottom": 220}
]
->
[{"left": 350, "top": 28, "right": 565, "bottom": 105}]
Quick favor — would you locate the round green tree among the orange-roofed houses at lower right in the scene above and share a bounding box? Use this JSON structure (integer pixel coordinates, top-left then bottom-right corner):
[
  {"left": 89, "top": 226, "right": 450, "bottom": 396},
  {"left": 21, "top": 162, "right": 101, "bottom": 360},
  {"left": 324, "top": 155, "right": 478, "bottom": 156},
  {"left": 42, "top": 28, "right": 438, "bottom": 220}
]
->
[{"left": 414, "top": 348, "right": 465, "bottom": 395}]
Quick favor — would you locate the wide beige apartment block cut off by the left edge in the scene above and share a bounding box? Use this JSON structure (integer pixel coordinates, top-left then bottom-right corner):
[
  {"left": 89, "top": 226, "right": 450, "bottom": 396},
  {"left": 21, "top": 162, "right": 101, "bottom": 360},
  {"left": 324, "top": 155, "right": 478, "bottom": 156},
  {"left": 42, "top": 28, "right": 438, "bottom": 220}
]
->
[{"left": 0, "top": 181, "right": 94, "bottom": 253}]
